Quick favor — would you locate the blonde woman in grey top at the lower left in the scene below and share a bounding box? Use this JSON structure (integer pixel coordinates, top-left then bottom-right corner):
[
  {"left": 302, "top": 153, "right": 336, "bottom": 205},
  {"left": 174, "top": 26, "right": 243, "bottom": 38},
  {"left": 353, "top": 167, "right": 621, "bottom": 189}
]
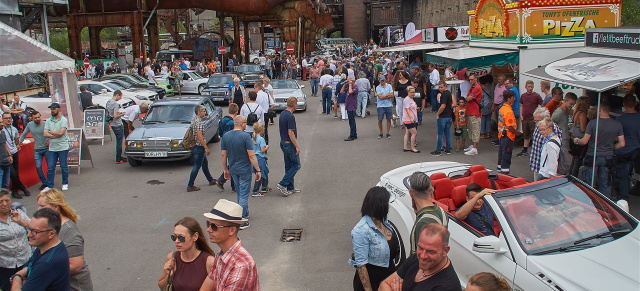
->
[{"left": 37, "top": 188, "right": 93, "bottom": 291}]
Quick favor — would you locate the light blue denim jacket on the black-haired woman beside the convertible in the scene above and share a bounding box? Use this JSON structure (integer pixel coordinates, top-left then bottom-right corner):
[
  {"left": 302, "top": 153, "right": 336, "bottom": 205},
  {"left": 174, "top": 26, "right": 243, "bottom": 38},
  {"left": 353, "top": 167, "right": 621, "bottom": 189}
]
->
[{"left": 349, "top": 215, "right": 391, "bottom": 267}]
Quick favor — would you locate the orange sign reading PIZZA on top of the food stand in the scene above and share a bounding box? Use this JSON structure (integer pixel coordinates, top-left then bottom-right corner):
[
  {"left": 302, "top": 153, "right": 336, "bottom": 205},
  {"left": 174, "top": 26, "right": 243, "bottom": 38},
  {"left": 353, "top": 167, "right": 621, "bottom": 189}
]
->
[{"left": 520, "top": 5, "right": 620, "bottom": 43}]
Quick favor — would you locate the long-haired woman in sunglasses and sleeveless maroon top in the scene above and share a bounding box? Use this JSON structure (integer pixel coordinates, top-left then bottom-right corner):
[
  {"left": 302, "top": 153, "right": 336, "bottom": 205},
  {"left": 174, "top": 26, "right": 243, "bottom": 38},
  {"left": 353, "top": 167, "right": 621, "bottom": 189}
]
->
[{"left": 158, "top": 217, "right": 214, "bottom": 291}]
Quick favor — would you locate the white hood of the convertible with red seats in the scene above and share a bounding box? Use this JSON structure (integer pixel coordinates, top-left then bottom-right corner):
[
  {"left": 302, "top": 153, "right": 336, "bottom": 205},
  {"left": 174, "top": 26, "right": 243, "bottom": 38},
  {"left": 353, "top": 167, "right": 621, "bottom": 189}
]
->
[{"left": 527, "top": 227, "right": 640, "bottom": 290}]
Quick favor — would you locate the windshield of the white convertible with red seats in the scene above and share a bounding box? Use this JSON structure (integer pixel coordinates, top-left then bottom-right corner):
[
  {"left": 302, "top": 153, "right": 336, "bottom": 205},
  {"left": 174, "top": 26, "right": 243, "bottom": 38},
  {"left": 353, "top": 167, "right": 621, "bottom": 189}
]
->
[{"left": 494, "top": 178, "right": 637, "bottom": 255}]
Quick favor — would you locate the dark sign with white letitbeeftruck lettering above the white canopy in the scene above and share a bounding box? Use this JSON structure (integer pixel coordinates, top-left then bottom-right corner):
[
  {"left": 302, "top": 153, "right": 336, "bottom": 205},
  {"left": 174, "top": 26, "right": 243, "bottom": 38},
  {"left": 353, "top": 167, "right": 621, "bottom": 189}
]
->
[{"left": 585, "top": 29, "right": 640, "bottom": 51}]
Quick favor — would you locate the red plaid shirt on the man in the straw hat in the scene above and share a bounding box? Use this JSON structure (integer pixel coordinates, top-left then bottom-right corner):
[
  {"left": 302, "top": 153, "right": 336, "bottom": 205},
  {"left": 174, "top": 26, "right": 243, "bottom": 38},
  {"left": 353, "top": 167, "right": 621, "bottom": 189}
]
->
[{"left": 208, "top": 240, "right": 260, "bottom": 291}]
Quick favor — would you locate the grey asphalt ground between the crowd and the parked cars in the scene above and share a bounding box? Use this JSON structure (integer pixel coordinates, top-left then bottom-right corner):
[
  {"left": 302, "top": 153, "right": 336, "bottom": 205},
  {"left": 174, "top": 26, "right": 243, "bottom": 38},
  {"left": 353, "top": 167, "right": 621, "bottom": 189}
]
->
[{"left": 21, "top": 82, "right": 640, "bottom": 291}]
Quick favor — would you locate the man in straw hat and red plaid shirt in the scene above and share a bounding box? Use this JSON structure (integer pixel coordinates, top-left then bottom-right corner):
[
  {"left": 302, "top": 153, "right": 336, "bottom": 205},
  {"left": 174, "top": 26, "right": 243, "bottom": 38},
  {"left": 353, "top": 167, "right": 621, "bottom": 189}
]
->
[{"left": 200, "top": 199, "right": 260, "bottom": 291}]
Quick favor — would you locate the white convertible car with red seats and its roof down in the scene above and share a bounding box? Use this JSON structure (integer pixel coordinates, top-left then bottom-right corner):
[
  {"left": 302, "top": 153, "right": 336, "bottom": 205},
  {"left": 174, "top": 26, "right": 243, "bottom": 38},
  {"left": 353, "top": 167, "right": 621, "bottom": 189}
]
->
[{"left": 378, "top": 162, "right": 640, "bottom": 291}]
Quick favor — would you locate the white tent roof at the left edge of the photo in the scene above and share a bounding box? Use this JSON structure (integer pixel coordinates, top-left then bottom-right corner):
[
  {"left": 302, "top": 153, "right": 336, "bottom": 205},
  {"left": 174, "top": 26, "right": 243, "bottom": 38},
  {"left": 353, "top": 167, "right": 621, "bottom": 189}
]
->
[{"left": 0, "top": 22, "right": 75, "bottom": 77}]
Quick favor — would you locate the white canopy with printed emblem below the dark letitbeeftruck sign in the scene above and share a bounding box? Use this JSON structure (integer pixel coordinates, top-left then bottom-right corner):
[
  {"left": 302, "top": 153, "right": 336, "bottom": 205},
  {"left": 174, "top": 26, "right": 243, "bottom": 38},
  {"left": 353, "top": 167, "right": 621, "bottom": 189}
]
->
[{"left": 522, "top": 47, "right": 640, "bottom": 92}]
